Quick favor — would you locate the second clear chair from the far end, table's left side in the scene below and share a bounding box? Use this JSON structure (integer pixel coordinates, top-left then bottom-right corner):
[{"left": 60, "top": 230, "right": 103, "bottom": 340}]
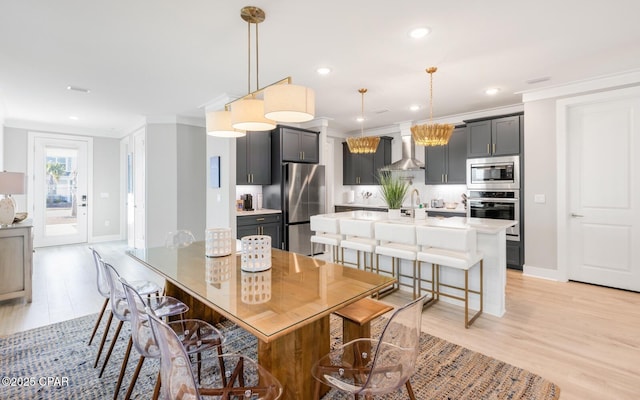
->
[{"left": 99, "top": 262, "right": 189, "bottom": 400}]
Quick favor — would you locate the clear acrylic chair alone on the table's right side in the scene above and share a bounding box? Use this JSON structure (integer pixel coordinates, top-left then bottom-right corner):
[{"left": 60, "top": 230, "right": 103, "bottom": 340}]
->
[{"left": 311, "top": 296, "right": 425, "bottom": 400}]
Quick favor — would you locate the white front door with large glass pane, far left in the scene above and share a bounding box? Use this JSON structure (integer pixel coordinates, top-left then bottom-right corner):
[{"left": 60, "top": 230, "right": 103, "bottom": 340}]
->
[{"left": 30, "top": 136, "right": 91, "bottom": 247}]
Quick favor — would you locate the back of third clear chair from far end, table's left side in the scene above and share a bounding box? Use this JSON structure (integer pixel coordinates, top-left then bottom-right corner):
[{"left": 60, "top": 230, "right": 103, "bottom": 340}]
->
[{"left": 120, "top": 277, "right": 160, "bottom": 358}]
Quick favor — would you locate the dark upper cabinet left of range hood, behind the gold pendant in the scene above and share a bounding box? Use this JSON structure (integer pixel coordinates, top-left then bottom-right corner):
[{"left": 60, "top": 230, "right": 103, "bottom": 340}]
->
[{"left": 342, "top": 136, "right": 393, "bottom": 185}]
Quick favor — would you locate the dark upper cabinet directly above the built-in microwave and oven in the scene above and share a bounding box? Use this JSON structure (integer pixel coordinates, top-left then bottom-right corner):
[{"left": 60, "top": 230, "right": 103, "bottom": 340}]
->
[{"left": 467, "top": 115, "right": 522, "bottom": 158}]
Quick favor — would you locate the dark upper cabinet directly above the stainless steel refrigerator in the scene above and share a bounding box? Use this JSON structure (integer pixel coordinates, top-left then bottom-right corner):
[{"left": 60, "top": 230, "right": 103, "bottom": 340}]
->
[{"left": 272, "top": 125, "right": 320, "bottom": 164}]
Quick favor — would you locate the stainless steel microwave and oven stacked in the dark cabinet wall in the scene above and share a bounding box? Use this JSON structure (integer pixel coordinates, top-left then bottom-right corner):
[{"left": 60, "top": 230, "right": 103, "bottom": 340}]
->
[{"left": 467, "top": 156, "right": 521, "bottom": 241}]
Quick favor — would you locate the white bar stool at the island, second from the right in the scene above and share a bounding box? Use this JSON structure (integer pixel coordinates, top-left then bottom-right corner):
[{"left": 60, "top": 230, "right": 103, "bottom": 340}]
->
[{"left": 374, "top": 222, "right": 419, "bottom": 299}]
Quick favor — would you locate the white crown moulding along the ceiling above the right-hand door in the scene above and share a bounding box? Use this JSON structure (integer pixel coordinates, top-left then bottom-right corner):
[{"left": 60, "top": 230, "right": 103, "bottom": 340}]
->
[{"left": 518, "top": 69, "right": 640, "bottom": 103}]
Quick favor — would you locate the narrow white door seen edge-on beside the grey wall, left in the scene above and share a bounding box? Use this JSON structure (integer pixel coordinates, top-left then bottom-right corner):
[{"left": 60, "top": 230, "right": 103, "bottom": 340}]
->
[{"left": 133, "top": 130, "right": 146, "bottom": 249}]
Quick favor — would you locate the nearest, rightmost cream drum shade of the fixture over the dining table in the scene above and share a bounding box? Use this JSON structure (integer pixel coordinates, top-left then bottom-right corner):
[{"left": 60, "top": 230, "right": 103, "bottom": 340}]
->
[{"left": 264, "top": 85, "right": 316, "bottom": 122}]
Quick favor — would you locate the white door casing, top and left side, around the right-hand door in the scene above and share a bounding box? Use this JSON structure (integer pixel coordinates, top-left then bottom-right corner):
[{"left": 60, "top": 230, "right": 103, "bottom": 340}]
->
[{"left": 556, "top": 86, "right": 640, "bottom": 281}]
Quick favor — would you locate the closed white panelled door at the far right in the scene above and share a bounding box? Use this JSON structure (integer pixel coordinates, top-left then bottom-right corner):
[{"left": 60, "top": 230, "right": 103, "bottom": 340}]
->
[{"left": 567, "top": 92, "right": 640, "bottom": 291}]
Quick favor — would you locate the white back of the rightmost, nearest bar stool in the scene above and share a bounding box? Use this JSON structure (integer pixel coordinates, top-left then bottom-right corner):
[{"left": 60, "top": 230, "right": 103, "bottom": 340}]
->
[{"left": 416, "top": 226, "right": 478, "bottom": 255}]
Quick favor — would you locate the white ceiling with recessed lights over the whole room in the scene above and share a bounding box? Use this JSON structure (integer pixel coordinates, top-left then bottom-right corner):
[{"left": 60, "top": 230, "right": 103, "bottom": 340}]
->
[{"left": 0, "top": 0, "right": 640, "bottom": 137}]
